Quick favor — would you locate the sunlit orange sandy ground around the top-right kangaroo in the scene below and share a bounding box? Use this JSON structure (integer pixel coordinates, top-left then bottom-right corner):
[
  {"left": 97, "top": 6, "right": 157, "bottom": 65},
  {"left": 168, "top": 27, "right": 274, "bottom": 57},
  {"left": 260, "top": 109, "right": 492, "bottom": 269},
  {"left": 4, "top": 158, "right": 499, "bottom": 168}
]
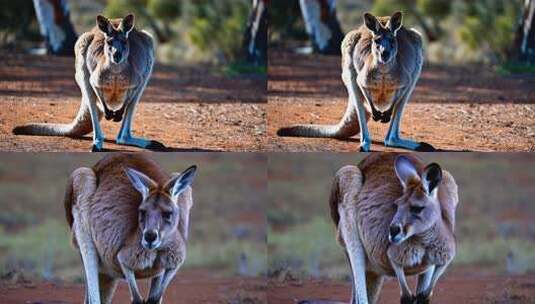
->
[{"left": 267, "top": 49, "right": 535, "bottom": 151}]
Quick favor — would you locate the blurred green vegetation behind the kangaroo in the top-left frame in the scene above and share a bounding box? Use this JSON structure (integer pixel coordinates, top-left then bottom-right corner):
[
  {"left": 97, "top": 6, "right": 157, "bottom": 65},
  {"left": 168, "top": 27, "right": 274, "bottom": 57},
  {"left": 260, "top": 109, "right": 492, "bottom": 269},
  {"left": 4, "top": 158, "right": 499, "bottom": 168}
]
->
[{"left": 0, "top": 0, "right": 260, "bottom": 65}]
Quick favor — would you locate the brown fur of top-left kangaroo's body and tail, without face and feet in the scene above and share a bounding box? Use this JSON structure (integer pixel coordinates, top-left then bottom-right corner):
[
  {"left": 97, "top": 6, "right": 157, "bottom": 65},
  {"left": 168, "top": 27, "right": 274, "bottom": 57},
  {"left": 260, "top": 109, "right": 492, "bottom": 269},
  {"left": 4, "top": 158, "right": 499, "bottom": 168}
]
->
[{"left": 13, "top": 15, "right": 154, "bottom": 146}]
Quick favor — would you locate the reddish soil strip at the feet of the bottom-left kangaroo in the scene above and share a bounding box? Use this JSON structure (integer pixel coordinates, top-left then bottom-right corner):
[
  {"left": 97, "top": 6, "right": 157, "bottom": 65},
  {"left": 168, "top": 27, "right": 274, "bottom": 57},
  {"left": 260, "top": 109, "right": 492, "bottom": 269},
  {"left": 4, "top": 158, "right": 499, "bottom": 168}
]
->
[{"left": 0, "top": 271, "right": 267, "bottom": 304}]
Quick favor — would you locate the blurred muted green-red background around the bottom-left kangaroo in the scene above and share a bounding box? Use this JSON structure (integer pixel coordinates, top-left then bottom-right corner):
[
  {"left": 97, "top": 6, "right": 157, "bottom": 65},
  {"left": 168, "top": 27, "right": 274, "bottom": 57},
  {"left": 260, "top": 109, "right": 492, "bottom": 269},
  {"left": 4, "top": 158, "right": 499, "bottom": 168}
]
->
[{"left": 0, "top": 153, "right": 267, "bottom": 282}]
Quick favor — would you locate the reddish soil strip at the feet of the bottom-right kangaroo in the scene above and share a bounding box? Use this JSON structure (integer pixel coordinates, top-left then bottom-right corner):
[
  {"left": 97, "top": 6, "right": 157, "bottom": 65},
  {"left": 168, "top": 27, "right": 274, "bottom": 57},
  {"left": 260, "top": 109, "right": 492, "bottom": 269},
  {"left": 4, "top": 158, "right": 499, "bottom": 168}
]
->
[{"left": 268, "top": 271, "right": 535, "bottom": 304}]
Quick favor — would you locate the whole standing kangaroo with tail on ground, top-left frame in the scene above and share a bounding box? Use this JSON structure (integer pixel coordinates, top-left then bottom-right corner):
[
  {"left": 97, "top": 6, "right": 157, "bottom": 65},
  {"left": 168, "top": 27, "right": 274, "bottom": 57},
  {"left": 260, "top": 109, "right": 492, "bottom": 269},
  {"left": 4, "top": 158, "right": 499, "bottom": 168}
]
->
[{"left": 13, "top": 14, "right": 165, "bottom": 151}]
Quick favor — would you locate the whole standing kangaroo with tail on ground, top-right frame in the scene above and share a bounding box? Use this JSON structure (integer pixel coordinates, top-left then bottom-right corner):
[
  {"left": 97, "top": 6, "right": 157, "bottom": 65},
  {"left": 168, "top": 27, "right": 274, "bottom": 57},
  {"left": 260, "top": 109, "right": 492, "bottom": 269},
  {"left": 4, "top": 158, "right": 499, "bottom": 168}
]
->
[{"left": 277, "top": 12, "right": 435, "bottom": 151}]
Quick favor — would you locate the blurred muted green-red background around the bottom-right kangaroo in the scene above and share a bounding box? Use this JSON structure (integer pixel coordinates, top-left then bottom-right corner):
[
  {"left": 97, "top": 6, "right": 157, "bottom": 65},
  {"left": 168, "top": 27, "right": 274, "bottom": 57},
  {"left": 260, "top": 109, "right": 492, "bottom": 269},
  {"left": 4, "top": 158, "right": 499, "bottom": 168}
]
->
[{"left": 267, "top": 153, "right": 535, "bottom": 279}]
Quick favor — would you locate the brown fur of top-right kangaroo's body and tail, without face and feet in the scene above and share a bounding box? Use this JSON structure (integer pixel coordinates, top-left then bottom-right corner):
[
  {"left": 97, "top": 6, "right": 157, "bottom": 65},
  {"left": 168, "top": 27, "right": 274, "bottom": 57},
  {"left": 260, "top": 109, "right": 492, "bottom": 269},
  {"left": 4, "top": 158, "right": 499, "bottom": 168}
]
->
[{"left": 277, "top": 13, "right": 423, "bottom": 151}]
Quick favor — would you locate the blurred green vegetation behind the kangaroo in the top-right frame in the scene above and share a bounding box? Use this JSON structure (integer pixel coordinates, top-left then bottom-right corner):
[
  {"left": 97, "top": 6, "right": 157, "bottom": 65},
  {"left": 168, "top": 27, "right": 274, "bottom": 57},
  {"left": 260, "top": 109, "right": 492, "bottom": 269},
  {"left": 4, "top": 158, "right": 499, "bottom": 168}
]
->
[{"left": 270, "top": 0, "right": 535, "bottom": 71}]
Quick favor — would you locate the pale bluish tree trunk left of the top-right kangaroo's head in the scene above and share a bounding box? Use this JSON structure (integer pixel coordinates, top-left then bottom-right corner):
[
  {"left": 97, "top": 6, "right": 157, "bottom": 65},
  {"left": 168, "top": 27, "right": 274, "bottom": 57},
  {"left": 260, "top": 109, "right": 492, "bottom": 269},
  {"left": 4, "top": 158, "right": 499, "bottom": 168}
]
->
[{"left": 299, "top": 0, "right": 344, "bottom": 55}]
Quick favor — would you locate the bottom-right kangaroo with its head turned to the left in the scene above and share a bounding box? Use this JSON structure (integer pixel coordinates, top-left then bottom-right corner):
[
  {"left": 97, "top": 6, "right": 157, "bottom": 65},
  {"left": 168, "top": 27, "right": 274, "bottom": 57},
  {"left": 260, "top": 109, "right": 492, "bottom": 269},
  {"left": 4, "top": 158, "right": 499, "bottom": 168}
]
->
[{"left": 302, "top": 153, "right": 459, "bottom": 304}]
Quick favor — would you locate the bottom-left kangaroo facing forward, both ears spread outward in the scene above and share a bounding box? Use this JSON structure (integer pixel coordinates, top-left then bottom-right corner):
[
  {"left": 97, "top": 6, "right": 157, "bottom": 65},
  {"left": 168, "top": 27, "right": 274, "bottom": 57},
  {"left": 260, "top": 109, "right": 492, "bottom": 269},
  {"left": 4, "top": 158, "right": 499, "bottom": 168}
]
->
[{"left": 65, "top": 154, "right": 196, "bottom": 304}]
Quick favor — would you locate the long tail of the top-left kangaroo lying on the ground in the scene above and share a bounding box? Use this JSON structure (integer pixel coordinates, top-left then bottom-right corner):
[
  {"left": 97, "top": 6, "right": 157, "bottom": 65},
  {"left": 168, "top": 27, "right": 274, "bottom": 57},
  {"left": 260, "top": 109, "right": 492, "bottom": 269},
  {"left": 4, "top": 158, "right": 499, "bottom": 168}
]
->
[{"left": 13, "top": 103, "right": 94, "bottom": 137}]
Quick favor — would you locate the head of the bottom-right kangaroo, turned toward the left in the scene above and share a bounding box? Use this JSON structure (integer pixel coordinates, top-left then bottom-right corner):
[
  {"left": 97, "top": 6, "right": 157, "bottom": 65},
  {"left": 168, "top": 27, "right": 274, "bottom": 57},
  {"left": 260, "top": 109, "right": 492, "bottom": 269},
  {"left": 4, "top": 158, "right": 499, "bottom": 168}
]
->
[{"left": 388, "top": 156, "right": 442, "bottom": 244}]
